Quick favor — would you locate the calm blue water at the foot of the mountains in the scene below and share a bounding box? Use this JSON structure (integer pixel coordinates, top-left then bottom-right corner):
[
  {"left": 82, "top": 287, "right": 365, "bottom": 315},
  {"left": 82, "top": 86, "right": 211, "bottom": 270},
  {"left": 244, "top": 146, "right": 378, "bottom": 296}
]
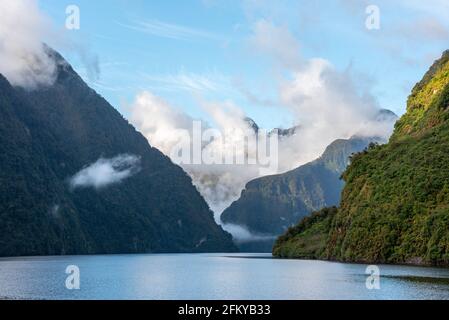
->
[{"left": 0, "top": 254, "right": 449, "bottom": 299}]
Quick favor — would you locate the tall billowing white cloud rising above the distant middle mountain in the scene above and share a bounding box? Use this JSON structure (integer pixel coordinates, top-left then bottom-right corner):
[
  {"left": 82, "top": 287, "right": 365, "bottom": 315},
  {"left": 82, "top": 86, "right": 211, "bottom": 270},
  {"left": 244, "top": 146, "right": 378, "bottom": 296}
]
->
[{"left": 248, "top": 20, "right": 393, "bottom": 172}]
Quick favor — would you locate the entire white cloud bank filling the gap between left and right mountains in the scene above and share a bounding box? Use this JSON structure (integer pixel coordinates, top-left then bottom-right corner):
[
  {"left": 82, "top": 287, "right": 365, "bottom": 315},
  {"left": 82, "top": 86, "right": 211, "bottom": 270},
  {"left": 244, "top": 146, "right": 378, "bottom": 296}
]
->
[{"left": 131, "top": 20, "right": 396, "bottom": 224}]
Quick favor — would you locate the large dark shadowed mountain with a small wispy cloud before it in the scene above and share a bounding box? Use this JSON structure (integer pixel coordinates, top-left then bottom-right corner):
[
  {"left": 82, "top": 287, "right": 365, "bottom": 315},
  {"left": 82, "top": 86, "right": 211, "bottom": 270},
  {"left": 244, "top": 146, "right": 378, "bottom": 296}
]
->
[{"left": 0, "top": 49, "right": 236, "bottom": 256}]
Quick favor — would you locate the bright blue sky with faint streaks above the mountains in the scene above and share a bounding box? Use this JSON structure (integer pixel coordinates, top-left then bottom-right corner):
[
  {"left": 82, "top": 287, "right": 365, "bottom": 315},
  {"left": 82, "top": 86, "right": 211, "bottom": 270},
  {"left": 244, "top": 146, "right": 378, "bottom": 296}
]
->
[{"left": 39, "top": 0, "right": 449, "bottom": 128}]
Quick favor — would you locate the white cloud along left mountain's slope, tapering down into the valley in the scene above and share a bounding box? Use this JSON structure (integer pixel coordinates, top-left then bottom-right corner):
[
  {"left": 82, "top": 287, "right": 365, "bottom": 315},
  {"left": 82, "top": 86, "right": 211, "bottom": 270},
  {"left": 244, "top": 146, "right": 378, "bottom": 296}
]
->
[{"left": 130, "top": 92, "right": 259, "bottom": 220}]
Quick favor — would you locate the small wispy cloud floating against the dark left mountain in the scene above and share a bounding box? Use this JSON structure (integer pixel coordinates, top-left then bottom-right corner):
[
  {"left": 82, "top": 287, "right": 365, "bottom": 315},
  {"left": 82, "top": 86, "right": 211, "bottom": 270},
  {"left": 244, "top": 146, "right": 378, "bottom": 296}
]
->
[{"left": 69, "top": 154, "right": 140, "bottom": 189}]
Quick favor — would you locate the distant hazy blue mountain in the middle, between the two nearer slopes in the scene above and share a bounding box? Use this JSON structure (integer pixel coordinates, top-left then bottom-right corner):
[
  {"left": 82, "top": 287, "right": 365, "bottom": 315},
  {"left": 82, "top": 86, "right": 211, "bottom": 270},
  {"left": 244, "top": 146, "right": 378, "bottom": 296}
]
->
[{"left": 221, "top": 137, "right": 377, "bottom": 251}]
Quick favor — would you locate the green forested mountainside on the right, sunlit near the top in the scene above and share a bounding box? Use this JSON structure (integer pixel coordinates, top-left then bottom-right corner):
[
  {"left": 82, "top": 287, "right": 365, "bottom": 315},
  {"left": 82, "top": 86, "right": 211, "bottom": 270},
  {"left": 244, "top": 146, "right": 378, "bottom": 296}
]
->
[{"left": 273, "top": 51, "right": 449, "bottom": 266}]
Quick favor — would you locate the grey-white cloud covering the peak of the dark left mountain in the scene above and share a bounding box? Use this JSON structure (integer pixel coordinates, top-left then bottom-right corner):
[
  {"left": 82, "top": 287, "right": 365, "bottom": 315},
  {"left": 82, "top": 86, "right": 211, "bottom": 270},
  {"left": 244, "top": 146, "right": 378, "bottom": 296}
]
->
[{"left": 0, "top": 0, "right": 100, "bottom": 90}]
